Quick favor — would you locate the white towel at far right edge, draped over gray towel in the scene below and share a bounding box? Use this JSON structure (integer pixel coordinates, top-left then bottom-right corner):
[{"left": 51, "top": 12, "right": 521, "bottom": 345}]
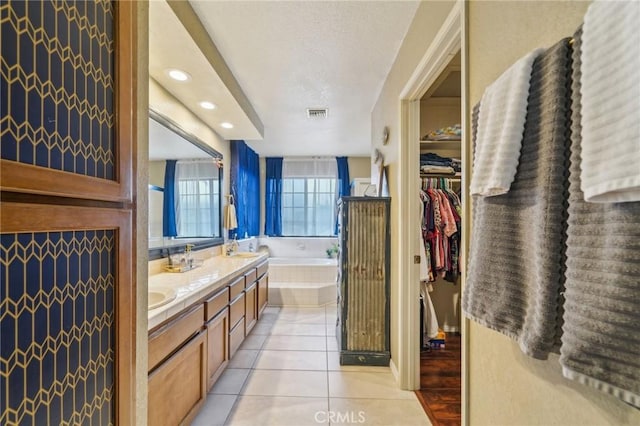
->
[{"left": 580, "top": 1, "right": 640, "bottom": 203}]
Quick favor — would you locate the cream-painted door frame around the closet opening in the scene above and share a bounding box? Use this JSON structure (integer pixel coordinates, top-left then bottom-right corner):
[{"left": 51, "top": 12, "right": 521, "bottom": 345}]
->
[{"left": 397, "top": 0, "right": 468, "bottom": 418}]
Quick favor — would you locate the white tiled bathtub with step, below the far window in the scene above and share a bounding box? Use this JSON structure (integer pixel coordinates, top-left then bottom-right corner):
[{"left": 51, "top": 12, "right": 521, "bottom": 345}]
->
[{"left": 269, "top": 257, "right": 338, "bottom": 306}]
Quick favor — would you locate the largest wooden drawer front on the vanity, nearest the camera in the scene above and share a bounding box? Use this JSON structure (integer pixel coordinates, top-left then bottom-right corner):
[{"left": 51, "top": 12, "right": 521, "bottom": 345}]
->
[{"left": 148, "top": 305, "right": 204, "bottom": 371}]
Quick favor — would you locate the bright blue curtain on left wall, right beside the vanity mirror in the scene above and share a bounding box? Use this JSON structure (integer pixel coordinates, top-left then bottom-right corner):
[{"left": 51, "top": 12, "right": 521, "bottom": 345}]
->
[{"left": 229, "top": 141, "right": 260, "bottom": 238}]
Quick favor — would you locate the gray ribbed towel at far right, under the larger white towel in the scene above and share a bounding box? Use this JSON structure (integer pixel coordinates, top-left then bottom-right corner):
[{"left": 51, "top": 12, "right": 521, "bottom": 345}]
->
[{"left": 560, "top": 30, "right": 640, "bottom": 407}]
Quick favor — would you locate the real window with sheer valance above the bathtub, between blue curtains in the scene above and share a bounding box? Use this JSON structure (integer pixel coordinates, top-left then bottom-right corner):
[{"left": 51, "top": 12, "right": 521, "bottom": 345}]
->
[{"left": 282, "top": 159, "right": 337, "bottom": 236}]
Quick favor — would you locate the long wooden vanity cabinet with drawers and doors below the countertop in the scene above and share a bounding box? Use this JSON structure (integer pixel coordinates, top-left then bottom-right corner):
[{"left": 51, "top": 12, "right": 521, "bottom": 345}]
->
[{"left": 148, "top": 262, "right": 268, "bottom": 425}]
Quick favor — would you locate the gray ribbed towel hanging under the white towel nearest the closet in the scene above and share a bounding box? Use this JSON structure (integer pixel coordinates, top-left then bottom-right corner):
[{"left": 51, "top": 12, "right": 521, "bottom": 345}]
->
[{"left": 462, "top": 40, "right": 570, "bottom": 359}]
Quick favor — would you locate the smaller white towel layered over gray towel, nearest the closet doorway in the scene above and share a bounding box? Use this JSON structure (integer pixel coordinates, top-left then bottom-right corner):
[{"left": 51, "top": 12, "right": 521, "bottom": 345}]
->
[{"left": 470, "top": 49, "right": 545, "bottom": 196}]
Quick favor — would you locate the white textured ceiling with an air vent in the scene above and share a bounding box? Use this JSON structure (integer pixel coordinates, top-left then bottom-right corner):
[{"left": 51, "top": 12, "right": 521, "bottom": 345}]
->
[{"left": 188, "top": 0, "right": 419, "bottom": 156}]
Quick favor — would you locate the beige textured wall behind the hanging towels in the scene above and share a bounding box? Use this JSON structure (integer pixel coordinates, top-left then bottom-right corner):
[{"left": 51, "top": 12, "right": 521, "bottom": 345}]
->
[{"left": 467, "top": 1, "right": 640, "bottom": 426}]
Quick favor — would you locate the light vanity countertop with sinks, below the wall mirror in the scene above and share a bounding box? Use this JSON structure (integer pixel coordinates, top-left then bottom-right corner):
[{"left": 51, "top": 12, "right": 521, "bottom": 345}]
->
[{"left": 148, "top": 252, "right": 269, "bottom": 330}]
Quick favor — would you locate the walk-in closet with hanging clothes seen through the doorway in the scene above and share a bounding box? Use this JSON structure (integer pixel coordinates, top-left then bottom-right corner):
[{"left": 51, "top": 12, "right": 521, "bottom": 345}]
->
[{"left": 417, "top": 53, "right": 463, "bottom": 424}]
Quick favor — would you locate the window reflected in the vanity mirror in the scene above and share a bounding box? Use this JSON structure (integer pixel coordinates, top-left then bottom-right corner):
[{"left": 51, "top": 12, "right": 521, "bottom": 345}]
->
[{"left": 176, "top": 161, "right": 221, "bottom": 237}]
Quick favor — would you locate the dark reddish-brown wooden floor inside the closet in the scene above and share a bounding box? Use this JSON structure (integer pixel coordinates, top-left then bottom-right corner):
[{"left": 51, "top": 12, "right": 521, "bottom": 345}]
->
[{"left": 416, "top": 335, "right": 462, "bottom": 426}]
